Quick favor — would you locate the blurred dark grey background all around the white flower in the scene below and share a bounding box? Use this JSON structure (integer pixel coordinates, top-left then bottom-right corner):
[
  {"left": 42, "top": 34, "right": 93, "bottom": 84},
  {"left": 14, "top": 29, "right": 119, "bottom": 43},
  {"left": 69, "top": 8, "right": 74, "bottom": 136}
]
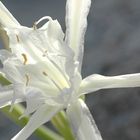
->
[{"left": 0, "top": 0, "right": 140, "bottom": 140}]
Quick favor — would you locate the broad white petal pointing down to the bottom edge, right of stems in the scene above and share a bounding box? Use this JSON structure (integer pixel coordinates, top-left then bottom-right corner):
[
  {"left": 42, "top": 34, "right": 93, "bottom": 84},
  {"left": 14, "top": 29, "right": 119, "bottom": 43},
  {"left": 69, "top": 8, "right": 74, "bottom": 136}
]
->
[{"left": 67, "top": 99, "right": 102, "bottom": 140}]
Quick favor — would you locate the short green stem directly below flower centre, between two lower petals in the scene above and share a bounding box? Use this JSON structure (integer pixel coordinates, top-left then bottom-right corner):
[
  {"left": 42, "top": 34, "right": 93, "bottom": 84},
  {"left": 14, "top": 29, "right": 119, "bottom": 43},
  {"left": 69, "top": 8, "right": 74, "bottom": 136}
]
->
[{"left": 51, "top": 111, "right": 75, "bottom": 140}]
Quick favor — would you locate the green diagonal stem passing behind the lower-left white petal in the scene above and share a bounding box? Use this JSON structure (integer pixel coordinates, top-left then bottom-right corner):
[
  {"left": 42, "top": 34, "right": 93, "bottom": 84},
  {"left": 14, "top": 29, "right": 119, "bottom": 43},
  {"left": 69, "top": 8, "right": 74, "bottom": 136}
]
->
[{"left": 2, "top": 105, "right": 64, "bottom": 140}]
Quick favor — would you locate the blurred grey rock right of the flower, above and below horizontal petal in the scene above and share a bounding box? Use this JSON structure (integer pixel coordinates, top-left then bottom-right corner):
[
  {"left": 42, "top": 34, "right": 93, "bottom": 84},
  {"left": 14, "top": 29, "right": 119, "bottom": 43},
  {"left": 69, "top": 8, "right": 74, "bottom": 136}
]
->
[{"left": 83, "top": 0, "right": 140, "bottom": 140}]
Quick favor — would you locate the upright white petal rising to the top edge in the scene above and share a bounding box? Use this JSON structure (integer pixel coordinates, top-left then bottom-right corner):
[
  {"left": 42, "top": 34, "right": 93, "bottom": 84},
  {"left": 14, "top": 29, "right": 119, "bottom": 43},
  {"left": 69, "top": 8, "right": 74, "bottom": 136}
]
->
[{"left": 66, "top": 0, "right": 91, "bottom": 69}]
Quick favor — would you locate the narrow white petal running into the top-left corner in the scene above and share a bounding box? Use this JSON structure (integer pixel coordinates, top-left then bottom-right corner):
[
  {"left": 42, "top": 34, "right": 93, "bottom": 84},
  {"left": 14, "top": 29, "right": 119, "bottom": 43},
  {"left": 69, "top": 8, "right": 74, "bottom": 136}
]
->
[{"left": 0, "top": 1, "right": 20, "bottom": 28}]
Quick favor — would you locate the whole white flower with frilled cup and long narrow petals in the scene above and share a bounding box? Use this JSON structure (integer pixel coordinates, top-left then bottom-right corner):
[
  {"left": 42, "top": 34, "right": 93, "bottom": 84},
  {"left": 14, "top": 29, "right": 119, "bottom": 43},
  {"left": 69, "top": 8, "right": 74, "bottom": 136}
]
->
[{"left": 0, "top": 0, "right": 140, "bottom": 140}]
